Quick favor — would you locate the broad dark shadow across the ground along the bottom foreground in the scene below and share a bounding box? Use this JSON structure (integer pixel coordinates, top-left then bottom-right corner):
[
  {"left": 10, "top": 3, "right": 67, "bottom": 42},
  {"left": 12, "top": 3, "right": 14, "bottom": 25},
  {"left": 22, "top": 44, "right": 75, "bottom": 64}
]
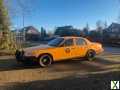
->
[{"left": 0, "top": 72, "right": 120, "bottom": 90}]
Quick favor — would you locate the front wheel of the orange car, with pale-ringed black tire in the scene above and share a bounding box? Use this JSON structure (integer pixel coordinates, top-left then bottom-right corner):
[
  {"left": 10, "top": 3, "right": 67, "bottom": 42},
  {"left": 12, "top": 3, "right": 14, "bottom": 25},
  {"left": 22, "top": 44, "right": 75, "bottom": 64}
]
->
[{"left": 38, "top": 54, "right": 53, "bottom": 67}]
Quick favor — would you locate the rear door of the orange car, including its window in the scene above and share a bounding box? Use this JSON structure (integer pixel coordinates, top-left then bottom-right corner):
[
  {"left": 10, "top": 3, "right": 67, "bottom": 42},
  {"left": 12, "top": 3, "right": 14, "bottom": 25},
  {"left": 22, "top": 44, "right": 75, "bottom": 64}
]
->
[{"left": 75, "top": 38, "right": 88, "bottom": 57}]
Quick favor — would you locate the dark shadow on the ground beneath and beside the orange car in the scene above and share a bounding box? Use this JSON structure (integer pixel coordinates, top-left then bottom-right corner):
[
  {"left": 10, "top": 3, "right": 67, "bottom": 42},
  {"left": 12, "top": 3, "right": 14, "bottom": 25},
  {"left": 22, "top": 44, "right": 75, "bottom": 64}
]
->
[{"left": 0, "top": 58, "right": 120, "bottom": 72}]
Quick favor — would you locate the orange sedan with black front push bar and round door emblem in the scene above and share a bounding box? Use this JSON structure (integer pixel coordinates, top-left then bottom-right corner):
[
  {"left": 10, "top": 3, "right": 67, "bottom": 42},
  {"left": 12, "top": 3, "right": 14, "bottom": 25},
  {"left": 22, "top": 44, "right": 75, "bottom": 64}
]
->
[{"left": 15, "top": 37, "right": 103, "bottom": 67}]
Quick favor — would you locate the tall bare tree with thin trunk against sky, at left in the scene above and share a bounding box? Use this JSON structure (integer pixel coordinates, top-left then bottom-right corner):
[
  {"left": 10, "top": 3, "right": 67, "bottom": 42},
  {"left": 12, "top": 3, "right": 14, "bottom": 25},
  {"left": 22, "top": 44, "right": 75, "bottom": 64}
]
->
[{"left": 5, "top": 0, "right": 33, "bottom": 41}]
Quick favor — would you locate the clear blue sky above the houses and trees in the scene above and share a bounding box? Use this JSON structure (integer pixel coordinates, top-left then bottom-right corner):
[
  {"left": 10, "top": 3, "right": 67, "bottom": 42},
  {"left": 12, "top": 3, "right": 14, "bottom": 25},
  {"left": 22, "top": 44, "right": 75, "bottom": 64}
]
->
[{"left": 11, "top": 0, "right": 120, "bottom": 30}]
